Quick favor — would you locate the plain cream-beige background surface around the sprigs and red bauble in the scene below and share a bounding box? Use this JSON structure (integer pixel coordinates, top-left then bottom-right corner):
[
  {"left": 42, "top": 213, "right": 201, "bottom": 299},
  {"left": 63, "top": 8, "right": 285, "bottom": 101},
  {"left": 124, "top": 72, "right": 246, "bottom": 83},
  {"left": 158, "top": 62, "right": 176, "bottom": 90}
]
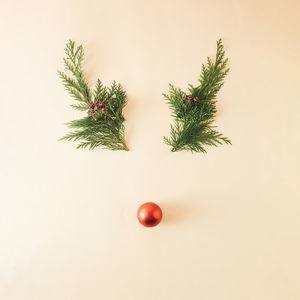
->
[{"left": 0, "top": 0, "right": 300, "bottom": 300}]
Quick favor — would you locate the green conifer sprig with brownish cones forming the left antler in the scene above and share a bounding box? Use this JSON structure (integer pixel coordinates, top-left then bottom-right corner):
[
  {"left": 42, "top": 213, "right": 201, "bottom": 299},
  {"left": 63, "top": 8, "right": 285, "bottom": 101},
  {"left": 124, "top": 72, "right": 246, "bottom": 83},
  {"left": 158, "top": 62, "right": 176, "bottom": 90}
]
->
[{"left": 58, "top": 40, "right": 129, "bottom": 151}]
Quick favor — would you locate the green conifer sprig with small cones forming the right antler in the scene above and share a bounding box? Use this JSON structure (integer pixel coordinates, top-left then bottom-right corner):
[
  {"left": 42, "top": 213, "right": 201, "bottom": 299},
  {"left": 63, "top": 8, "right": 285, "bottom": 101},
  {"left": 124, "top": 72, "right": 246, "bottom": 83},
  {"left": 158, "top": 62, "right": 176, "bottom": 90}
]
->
[{"left": 163, "top": 39, "right": 231, "bottom": 153}]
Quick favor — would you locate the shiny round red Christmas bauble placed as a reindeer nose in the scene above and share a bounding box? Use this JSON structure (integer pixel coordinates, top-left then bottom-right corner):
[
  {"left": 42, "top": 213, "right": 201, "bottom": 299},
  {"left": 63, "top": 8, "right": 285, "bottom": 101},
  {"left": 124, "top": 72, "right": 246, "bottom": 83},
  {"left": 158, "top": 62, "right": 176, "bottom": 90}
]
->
[{"left": 137, "top": 202, "right": 162, "bottom": 227}]
